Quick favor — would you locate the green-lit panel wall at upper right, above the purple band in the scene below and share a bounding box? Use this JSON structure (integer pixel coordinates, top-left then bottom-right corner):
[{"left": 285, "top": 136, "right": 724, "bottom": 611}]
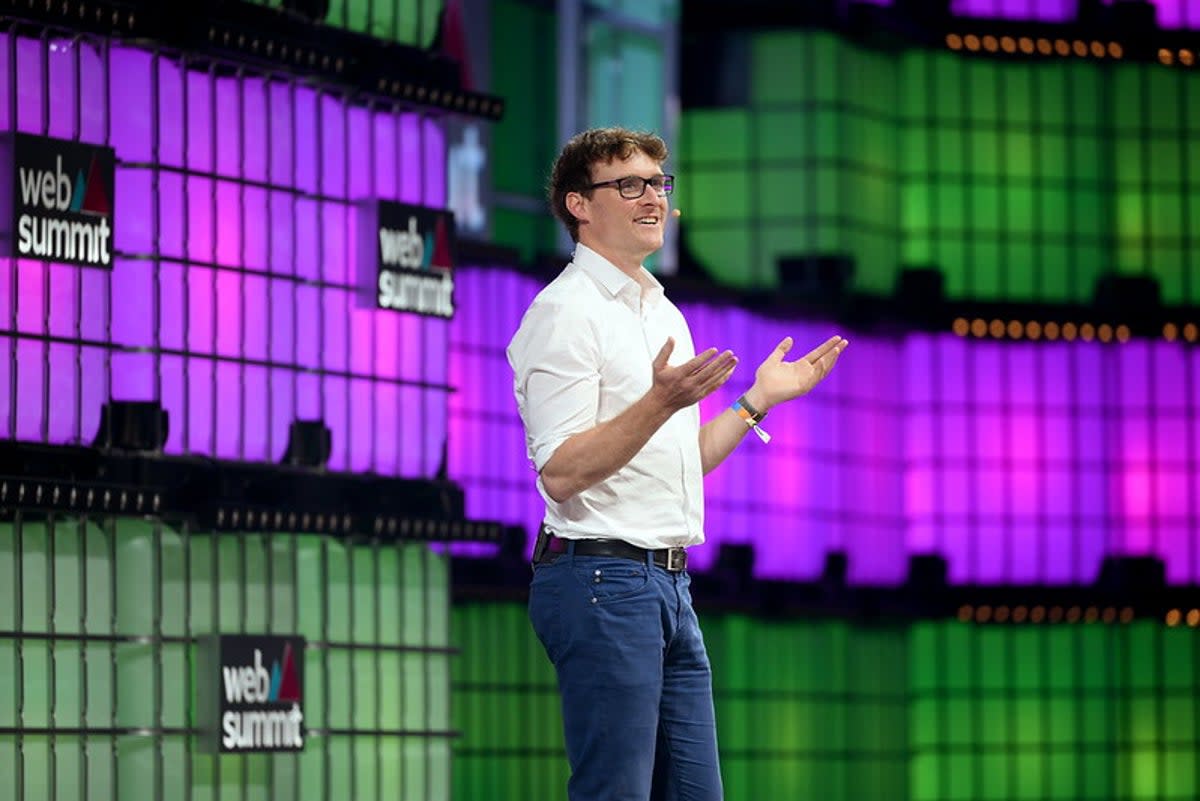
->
[{"left": 676, "top": 31, "right": 1200, "bottom": 306}]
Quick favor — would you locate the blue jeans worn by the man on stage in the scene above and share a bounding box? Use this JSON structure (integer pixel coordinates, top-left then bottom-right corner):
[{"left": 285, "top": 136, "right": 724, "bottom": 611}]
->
[{"left": 529, "top": 547, "right": 722, "bottom": 801}]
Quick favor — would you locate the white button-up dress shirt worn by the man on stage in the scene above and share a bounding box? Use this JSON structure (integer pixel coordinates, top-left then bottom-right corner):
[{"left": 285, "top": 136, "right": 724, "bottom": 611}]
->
[{"left": 508, "top": 245, "right": 704, "bottom": 548}]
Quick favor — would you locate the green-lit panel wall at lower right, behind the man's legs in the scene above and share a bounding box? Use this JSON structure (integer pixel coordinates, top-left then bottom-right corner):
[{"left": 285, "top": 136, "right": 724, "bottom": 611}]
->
[{"left": 451, "top": 603, "right": 1200, "bottom": 801}]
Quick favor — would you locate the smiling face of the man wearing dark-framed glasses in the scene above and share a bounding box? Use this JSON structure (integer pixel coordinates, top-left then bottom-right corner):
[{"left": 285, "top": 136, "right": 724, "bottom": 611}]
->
[{"left": 576, "top": 150, "right": 667, "bottom": 269}]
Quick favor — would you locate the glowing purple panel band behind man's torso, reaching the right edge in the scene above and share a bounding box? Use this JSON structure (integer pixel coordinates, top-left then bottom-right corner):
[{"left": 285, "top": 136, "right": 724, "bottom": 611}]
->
[{"left": 449, "top": 269, "right": 1200, "bottom": 584}]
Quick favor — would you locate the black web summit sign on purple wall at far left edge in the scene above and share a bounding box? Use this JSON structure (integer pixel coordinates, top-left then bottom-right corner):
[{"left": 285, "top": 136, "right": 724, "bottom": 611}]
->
[{"left": 0, "top": 133, "right": 115, "bottom": 269}]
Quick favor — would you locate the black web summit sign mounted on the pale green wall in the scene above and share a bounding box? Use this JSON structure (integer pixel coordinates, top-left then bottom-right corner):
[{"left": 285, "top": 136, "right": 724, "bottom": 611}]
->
[{"left": 199, "top": 634, "right": 305, "bottom": 753}]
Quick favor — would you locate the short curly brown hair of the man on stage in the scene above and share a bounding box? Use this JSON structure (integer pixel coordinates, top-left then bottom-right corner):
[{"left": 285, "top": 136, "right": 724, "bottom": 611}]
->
[{"left": 546, "top": 128, "right": 667, "bottom": 242}]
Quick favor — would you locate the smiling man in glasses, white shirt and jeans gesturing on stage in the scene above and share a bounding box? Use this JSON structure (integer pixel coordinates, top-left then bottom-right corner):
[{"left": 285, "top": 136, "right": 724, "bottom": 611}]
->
[{"left": 508, "top": 128, "right": 847, "bottom": 801}]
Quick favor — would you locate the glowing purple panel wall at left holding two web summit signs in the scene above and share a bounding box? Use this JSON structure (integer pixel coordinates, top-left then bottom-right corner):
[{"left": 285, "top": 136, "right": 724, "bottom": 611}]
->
[{"left": 0, "top": 35, "right": 450, "bottom": 477}]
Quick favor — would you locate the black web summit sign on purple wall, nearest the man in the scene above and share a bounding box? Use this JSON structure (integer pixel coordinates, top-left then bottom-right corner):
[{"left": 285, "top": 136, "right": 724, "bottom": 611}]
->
[{"left": 359, "top": 200, "right": 455, "bottom": 318}]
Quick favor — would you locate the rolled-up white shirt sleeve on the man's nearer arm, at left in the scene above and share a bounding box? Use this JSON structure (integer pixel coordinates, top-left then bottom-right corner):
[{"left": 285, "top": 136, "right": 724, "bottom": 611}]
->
[{"left": 508, "top": 302, "right": 600, "bottom": 472}]
